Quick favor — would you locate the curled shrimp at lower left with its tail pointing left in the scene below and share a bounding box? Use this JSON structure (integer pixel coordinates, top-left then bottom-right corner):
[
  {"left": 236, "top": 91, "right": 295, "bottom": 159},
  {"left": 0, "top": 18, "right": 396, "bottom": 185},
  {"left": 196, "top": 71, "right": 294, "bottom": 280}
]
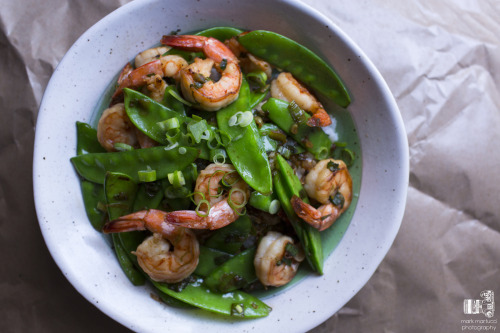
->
[{"left": 103, "top": 209, "right": 200, "bottom": 283}]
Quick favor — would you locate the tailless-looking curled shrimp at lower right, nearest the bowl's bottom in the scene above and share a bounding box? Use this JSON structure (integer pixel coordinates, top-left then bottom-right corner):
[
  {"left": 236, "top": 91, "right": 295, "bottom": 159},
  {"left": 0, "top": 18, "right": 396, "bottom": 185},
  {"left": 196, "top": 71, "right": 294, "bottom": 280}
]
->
[{"left": 254, "top": 231, "right": 305, "bottom": 287}]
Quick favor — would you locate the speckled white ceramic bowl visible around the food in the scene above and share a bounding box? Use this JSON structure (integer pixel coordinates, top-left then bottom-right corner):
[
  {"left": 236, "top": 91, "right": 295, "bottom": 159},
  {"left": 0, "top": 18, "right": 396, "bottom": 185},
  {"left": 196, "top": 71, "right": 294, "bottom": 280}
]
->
[{"left": 33, "top": 0, "right": 408, "bottom": 332}]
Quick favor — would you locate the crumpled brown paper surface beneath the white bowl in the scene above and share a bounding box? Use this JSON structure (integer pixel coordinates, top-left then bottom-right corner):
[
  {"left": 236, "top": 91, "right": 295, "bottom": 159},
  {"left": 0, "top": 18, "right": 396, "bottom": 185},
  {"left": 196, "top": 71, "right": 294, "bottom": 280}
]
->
[{"left": 0, "top": 0, "right": 500, "bottom": 333}]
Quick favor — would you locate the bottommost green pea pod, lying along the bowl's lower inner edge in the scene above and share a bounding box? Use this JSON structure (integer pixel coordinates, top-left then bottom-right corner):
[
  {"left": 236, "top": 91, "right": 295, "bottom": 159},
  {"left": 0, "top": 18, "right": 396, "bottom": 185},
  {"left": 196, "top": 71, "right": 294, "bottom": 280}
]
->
[{"left": 152, "top": 279, "right": 271, "bottom": 318}]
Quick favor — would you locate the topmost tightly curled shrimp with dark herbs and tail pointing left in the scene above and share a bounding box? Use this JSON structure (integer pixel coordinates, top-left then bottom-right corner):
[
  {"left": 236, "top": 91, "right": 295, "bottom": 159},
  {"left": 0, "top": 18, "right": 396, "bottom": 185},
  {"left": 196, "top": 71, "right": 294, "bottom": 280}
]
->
[{"left": 161, "top": 35, "right": 242, "bottom": 111}]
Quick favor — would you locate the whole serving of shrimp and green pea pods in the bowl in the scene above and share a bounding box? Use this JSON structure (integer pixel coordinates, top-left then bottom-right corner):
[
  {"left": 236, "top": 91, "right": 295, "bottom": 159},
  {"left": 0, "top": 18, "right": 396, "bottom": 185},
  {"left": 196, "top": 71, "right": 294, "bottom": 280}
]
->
[{"left": 71, "top": 27, "right": 359, "bottom": 318}]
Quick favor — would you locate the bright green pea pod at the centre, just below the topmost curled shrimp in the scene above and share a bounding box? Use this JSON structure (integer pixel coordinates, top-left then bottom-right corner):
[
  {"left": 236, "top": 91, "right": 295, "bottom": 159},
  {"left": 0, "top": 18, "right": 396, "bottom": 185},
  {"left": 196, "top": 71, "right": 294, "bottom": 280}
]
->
[{"left": 217, "top": 79, "right": 272, "bottom": 194}]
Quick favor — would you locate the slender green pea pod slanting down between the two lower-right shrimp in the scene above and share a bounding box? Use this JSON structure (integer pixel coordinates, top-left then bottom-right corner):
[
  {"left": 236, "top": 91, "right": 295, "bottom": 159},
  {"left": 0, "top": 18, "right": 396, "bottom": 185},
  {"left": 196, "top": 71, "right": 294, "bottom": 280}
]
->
[{"left": 273, "top": 154, "right": 323, "bottom": 274}]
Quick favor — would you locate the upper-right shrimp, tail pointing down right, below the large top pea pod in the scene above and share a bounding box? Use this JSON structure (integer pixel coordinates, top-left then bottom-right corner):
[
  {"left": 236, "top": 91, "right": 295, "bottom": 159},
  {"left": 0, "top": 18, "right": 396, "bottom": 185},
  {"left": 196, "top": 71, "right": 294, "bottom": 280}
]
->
[{"left": 271, "top": 72, "right": 332, "bottom": 127}]
